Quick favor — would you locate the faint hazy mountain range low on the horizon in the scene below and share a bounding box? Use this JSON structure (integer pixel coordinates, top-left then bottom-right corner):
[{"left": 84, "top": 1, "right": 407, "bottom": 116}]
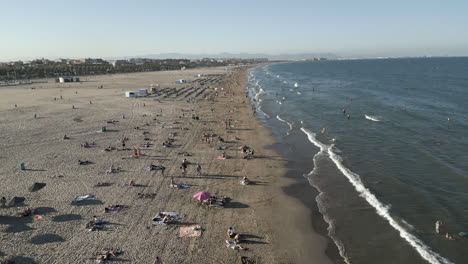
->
[{"left": 106, "top": 53, "right": 338, "bottom": 60}]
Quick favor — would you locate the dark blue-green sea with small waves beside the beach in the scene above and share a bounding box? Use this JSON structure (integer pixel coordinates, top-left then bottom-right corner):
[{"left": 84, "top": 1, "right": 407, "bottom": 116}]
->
[{"left": 248, "top": 58, "right": 468, "bottom": 263}]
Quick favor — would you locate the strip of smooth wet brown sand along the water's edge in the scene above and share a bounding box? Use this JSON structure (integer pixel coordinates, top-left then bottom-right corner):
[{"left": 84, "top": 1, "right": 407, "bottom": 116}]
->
[{"left": 249, "top": 66, "right": 336, "bottom": 264}]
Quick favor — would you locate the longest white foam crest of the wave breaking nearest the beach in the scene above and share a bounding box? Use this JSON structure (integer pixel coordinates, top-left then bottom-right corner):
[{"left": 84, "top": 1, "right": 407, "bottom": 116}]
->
[{"left": 301, "top": 127, "right": 452, "bottom": 264}]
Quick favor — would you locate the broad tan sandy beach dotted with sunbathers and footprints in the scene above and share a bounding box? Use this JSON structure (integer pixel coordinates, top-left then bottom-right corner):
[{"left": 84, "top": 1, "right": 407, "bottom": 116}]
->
[{"left": 0, "top": 68, "right": 328, "bottom": 263}]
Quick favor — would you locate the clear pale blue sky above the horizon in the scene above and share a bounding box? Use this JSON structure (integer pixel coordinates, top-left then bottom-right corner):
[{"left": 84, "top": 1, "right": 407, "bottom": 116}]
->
[{"left": 0, "top": 0, "right": 468, "bottom": 61}]
